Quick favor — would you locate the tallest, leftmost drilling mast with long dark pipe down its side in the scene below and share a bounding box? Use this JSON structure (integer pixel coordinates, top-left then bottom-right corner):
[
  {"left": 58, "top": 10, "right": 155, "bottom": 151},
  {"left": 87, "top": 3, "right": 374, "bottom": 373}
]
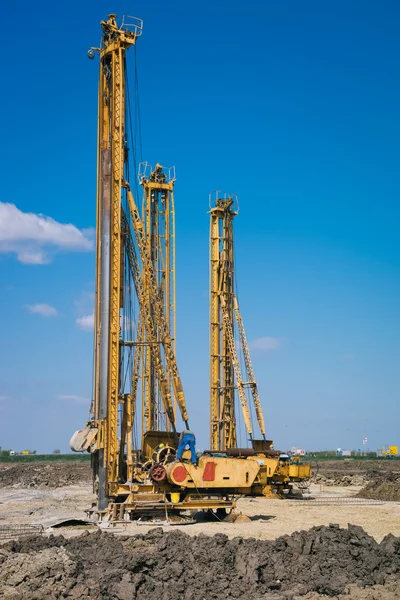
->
[{"left": 94, "top": 14, "right": 142, "bottom": 510}]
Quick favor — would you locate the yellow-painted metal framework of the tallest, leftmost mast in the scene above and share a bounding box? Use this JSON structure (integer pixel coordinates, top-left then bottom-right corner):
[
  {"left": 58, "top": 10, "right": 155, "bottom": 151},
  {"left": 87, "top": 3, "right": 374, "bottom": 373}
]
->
[{"left": 93, "top": 15, "right": 141, "bottom": 486}]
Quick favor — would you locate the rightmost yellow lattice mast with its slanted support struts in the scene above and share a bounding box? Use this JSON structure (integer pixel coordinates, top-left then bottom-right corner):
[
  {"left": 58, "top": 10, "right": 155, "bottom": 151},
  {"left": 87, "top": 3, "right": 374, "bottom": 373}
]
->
[{"left": 210, "top": 193, "right": 265, "bottom": 450}]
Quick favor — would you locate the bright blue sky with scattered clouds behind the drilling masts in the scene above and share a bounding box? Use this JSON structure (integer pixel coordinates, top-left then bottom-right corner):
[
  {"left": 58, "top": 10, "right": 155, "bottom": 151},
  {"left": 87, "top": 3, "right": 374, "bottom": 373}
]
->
[{"left": 0, "top": 0, "right": 400, "bottom": 451}]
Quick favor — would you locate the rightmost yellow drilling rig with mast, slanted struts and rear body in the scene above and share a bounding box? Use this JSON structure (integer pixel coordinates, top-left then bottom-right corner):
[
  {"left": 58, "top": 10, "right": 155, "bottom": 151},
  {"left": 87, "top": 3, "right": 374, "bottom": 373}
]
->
[{"left": 210, "top": 192, "right": 311, "bottom": 495}]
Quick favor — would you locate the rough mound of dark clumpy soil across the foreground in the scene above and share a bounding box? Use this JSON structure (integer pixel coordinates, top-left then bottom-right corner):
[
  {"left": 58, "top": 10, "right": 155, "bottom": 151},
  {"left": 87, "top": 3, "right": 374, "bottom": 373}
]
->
[{"left": 0, "top": 525, "right": 400, "bottom": 600}]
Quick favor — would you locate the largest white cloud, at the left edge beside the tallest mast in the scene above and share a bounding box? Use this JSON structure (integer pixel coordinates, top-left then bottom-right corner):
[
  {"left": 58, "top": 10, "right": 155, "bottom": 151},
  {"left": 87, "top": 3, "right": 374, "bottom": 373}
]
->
[{"left": 0, "top": 202, "right": 93, "bottom": 265}]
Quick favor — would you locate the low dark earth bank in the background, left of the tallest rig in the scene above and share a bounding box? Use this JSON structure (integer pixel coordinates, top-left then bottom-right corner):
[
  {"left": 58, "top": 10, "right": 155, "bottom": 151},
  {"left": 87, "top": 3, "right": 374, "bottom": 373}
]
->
[{"left": 0, "top": 462, "right": 91, "bottom": 488}]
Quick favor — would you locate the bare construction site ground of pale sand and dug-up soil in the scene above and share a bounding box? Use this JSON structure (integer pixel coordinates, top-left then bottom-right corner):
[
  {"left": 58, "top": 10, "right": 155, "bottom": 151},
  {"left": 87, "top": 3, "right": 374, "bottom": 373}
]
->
[{"left": 0, "top": 460, "right": 400, "bottom": 600}]
